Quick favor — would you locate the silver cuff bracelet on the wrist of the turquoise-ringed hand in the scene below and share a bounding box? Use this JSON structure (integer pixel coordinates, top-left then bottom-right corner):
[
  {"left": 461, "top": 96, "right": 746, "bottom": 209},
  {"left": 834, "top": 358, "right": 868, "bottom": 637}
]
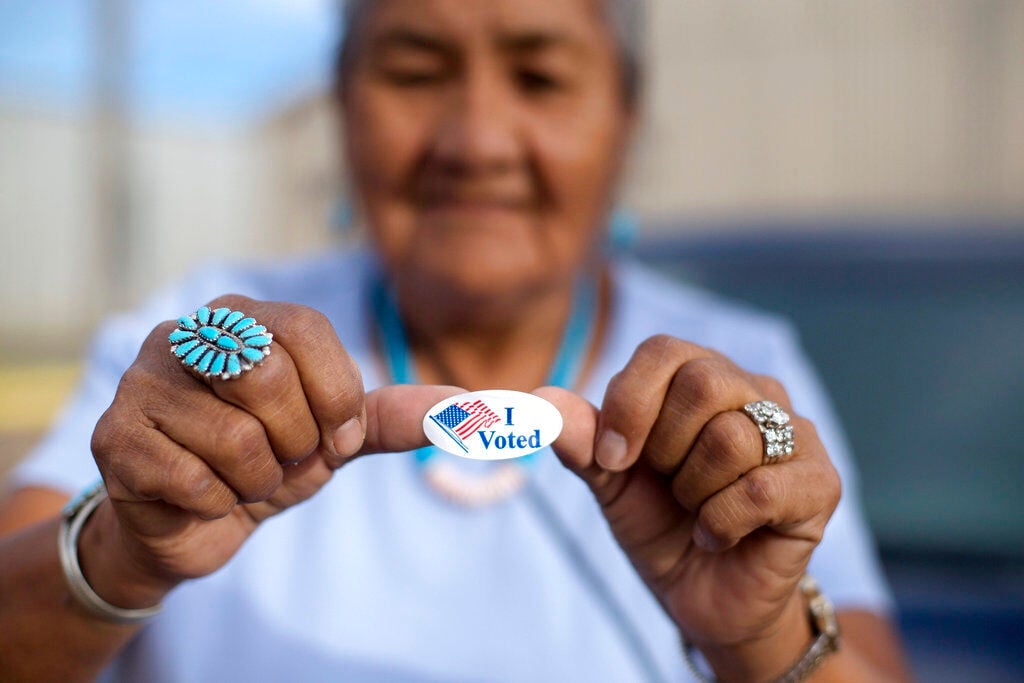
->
[{"left": 57, "top": 479, "right": 164, "bottom": 624}]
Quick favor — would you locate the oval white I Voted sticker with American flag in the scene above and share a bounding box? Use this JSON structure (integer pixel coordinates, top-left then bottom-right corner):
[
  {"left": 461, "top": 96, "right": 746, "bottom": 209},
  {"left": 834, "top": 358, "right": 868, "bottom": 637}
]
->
[{"left": 423, "top": 389, "right": 562, "bottom": 460}]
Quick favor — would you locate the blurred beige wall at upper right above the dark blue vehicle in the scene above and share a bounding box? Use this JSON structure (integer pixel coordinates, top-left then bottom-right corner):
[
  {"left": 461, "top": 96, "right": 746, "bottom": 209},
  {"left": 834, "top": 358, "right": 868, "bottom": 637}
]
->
[{"left": 628, "top": 0, "right": 1024, "bottom": 225}]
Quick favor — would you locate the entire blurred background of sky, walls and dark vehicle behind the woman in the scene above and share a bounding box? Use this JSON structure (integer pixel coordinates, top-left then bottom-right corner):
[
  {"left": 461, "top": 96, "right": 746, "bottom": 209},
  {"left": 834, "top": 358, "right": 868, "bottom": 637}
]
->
[{"left": 0, "top": 0, "right": 1024, "bottom": 681}]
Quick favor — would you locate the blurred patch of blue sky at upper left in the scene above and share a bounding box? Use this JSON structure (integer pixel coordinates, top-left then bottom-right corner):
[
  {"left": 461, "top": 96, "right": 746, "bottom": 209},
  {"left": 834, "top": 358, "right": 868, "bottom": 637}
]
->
[{"left": 0, "top": 0, "right": 339, "bottom": 125}]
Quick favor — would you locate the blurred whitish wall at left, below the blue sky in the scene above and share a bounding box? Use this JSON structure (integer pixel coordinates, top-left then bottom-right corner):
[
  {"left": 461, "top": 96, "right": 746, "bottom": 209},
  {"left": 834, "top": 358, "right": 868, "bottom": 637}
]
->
[{"left": 0, "top": 112, "right": 272, "bottom": 356}]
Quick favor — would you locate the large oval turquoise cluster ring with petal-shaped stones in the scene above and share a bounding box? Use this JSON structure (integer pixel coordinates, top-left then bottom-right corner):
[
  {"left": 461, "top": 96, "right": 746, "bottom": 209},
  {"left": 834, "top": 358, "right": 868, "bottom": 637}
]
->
[{"left": 167, "top": 306, "right": 273, "bottom": 380}]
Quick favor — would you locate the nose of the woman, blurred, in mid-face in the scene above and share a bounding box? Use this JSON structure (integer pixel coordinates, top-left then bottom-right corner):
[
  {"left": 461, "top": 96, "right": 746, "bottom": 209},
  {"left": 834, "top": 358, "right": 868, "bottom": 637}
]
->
[{"left": 434, "top": 73, "right": 522, "bottom": 173}]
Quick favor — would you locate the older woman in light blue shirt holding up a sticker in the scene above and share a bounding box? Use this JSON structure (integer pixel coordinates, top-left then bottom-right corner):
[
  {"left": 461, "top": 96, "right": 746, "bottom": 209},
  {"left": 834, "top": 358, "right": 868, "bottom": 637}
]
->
[{"left": 0, "top": 0, "right": 905, "bottom": 681}]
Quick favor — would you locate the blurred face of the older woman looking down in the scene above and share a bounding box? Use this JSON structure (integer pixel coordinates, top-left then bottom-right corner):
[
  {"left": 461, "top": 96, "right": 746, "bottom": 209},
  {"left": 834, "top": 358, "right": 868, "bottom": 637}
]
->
[{"left": 341, "top": 0, "right": 632, "bottom": 297}]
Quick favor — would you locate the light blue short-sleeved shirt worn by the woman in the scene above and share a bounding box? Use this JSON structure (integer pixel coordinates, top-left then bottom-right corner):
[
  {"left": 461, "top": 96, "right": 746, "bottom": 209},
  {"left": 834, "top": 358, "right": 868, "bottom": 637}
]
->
[{"left": 8, "top": 251, "right": 891, "bottom": 683}]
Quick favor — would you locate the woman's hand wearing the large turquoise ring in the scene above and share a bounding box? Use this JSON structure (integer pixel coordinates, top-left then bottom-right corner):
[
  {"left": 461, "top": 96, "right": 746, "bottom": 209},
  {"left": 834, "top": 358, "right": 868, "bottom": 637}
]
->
[{"left": 86, "top": 296, "right": 458, "bottom": 607}]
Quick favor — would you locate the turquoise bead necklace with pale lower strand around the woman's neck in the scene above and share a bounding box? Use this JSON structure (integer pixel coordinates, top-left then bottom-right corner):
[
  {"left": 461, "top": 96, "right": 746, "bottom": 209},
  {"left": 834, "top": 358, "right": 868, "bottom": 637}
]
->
[{"left": 372, "top": 276, "right": 598, "bottom": 507}]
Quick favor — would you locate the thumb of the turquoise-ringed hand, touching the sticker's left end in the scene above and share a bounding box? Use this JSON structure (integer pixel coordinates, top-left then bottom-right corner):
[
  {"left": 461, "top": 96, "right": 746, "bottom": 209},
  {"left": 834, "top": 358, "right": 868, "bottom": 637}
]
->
[{"left": 355, "top": 384, "right": 466, "bottom": 456}]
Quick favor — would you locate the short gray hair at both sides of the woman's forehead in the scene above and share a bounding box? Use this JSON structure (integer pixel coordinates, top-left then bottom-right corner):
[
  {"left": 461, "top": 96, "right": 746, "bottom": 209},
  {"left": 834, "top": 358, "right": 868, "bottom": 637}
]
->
[{"left": 335, "top": 0, "right": 646, "bottom": 105}]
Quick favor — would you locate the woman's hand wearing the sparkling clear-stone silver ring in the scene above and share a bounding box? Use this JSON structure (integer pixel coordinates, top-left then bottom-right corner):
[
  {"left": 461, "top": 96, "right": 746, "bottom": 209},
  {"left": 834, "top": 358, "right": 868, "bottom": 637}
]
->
[{"left": 537, "top": 336, "right": 840, "bottom": 680}]
